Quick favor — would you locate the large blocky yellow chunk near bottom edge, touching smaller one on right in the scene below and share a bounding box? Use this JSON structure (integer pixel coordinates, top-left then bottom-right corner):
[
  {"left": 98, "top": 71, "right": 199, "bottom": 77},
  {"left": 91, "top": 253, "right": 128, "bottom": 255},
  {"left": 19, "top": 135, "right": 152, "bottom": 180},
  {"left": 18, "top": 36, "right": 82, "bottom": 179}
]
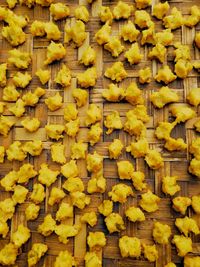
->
[{"left": 119, "top": 238, "right": 142, "bottom": 258}]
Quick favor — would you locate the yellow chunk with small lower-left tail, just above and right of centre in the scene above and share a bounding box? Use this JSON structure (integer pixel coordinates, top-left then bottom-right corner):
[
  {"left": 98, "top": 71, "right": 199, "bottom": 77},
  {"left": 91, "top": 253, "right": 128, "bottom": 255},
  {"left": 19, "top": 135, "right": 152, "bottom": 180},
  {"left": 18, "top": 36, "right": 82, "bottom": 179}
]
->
[{"left": 104, "top": 110, "right": 123, "bottom": 134}]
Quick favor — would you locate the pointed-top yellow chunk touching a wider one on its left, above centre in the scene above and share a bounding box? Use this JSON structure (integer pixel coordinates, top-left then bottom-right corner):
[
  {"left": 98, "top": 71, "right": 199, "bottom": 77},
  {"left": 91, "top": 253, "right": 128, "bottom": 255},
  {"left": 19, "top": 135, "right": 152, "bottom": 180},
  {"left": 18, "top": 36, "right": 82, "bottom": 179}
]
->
[{"left": 125, "top": 82, "right": 144, "bottom": 105}]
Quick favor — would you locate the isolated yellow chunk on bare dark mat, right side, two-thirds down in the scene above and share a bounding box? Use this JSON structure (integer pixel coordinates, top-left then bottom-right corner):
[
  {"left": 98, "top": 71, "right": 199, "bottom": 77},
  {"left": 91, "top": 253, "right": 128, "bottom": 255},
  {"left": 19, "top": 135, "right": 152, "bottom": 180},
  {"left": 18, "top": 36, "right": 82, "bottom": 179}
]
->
[{"left": 162, "top": 176, "right": 181, "bottom": 196}]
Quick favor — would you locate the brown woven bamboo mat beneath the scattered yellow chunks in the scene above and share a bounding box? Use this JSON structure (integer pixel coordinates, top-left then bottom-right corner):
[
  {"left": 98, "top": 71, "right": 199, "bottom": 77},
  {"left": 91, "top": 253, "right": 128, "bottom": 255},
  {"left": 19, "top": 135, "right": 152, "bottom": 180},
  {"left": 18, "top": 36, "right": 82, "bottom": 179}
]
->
[{"left": 0, "top": 0, "right": 200, "bottom": 267}]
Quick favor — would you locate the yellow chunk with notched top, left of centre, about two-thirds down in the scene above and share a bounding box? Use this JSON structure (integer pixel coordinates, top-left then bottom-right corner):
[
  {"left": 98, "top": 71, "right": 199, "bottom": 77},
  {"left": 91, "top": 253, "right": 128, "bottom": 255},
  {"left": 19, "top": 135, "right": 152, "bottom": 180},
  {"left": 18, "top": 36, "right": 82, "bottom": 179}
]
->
[{"left": 38, "top": 163, "right": 60, "bottom": 187}]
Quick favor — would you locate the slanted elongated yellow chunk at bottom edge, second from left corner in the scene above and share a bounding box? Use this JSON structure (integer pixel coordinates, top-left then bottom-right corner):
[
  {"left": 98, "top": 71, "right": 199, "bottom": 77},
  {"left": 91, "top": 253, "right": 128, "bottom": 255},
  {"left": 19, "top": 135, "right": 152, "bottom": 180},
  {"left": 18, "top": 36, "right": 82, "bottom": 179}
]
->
[{"left": 28, "top": 243, "right": 48, "bottom": 267}]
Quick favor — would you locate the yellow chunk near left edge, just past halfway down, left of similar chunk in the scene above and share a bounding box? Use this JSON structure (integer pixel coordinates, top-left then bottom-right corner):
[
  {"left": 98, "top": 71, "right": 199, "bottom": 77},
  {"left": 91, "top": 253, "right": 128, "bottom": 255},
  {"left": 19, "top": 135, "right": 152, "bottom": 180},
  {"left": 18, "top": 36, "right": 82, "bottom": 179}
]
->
[{"left": 6, "top": 141, "right": 27, "bottom": 161}]
